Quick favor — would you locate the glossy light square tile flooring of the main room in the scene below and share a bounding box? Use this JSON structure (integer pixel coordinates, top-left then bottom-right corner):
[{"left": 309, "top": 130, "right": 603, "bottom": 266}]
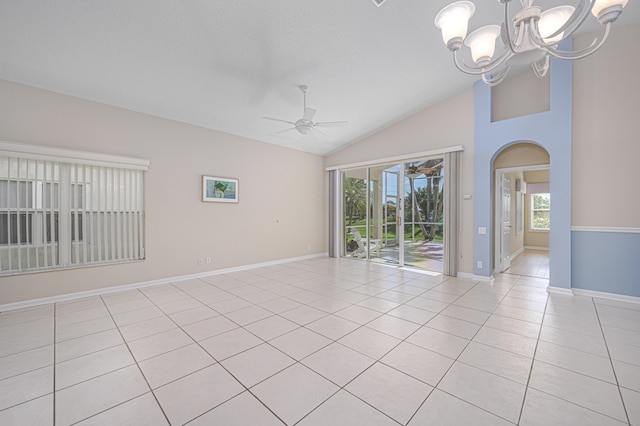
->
[{"left": 0, "top": 258, "right": 640, "bottom": 426}]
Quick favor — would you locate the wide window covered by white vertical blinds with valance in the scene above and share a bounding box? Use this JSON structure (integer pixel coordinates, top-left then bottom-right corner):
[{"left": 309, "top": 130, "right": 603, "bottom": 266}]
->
[{"left": 0, "top": 142, "right": 148, "bottom": 275}]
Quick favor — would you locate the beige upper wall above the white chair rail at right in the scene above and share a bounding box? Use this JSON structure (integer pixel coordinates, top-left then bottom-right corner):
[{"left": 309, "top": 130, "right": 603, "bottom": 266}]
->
[{"left": 571, "top": 24, "right": 640, "bottom": 228}]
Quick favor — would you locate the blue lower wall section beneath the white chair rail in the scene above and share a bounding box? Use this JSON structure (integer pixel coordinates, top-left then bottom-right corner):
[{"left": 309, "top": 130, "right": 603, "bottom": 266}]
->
[{"left": 571, "top": 231, "right": 640, "bottom": 297}]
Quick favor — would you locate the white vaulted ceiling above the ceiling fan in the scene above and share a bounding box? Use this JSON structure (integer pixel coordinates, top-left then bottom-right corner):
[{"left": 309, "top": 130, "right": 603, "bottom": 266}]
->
[{"left": 0, "top": 0, "right": 640, "bottom": 155}]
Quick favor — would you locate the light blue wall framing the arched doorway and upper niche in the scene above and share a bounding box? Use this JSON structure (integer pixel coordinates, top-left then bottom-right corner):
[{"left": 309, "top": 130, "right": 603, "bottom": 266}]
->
[{"left": 473, "top": 40, "right": 573, "bottom": 289}]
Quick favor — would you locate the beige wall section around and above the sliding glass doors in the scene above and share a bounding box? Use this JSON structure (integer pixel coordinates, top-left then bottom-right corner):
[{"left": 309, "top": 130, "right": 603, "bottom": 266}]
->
[{"left": 326, "top": 89, "right": 474, "bottom": 273}]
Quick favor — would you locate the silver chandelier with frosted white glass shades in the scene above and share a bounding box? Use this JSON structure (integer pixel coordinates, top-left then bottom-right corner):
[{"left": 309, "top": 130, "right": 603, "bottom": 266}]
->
[{"left": 435, "top": 0, "right": 628, "bottom": 86}]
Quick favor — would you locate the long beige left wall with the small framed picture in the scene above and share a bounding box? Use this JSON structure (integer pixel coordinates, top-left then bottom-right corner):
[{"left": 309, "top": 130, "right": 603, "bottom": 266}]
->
[{"left": 0, "top": 80, "right": 328, "bottom": 304}]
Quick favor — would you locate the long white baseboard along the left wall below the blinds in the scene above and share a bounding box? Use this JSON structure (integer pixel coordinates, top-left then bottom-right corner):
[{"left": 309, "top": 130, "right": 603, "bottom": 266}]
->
[{"left": 0, "top": 253, "right": 328, "bottom": 312}]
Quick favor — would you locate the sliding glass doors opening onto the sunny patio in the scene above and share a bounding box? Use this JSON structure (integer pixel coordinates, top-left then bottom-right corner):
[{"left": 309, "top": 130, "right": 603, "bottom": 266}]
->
[{"left": 341, "top": 157, "right": 446, "bottom": 273}]
